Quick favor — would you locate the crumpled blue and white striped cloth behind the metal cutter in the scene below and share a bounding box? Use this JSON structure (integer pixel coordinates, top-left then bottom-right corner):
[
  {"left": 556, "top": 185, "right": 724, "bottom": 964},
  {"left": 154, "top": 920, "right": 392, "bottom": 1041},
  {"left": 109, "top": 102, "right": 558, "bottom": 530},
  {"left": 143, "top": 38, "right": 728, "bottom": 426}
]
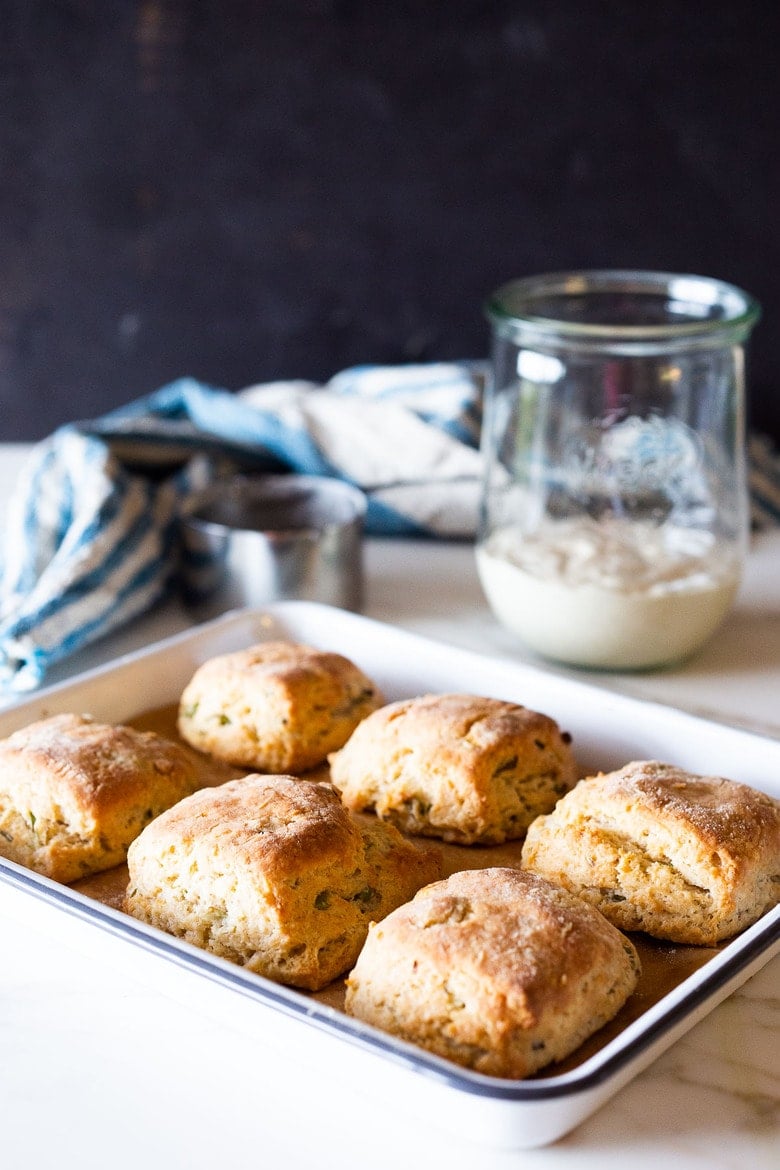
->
[{"left": 0, "top": 363, "right": 484, "bottom": 690}]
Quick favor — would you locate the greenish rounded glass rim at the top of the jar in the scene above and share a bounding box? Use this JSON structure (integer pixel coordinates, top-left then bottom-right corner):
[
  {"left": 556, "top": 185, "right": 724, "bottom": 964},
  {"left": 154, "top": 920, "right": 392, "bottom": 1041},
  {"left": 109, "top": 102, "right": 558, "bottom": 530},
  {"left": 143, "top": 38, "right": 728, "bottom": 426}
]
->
[{"left": 484, "top": 269, "right": 761, "bottom": 344}]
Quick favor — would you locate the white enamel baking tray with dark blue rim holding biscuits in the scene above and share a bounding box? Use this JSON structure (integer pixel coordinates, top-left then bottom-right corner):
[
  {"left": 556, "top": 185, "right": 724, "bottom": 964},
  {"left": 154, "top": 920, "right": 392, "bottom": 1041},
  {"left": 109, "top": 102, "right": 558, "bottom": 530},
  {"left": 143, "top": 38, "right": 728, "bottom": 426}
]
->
[{"left": 0, "top": 601, "right": 780, "bottom": 1149}]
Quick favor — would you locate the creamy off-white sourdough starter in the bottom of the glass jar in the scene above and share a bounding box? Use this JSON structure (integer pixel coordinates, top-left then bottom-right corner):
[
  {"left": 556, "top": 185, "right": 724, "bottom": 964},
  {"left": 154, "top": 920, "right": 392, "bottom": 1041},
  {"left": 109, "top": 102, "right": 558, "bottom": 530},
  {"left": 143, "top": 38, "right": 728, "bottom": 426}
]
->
[{"left": 477, "top": 517, "right": 739, "bottom": 670}]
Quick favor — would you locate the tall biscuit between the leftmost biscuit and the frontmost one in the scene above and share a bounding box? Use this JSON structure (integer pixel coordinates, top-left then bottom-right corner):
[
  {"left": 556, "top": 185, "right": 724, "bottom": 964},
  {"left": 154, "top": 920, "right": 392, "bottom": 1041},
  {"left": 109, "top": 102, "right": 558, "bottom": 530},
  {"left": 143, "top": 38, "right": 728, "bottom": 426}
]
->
[{"left": 125, "top": 775, "right": 441, "bottom": 991}]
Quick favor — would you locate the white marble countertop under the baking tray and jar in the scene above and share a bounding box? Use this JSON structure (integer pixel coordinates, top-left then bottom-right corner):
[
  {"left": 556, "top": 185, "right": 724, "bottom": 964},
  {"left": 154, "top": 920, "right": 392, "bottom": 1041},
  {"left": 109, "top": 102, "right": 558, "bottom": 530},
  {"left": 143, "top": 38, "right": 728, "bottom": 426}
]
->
[{"left": 0, "top": 445, "right": 780, "bottom": 1170}]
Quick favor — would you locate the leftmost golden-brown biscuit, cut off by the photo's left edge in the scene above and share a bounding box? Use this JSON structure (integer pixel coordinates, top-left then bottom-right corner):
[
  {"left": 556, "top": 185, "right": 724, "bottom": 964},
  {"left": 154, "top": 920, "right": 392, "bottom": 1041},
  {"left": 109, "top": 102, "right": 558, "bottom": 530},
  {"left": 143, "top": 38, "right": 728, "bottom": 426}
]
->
[{"left": 0, "top": 715, "right": 212, "bottom": 882}]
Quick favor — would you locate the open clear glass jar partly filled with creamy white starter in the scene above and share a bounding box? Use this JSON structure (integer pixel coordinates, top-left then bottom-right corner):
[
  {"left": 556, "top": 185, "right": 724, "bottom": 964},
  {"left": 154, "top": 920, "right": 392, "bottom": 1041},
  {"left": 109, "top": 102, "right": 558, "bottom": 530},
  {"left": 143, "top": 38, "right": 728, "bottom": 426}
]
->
[{"left": 476, "top": 271, "right": 760, "bottom": 669}]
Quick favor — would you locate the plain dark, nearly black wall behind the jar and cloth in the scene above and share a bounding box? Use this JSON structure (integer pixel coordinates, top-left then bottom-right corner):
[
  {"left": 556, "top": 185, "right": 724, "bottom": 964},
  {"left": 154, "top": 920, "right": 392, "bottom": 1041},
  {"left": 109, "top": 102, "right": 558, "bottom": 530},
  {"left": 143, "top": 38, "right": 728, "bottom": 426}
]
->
[{"left": 0, "top": 0, "right": 780, "bottom": 439}]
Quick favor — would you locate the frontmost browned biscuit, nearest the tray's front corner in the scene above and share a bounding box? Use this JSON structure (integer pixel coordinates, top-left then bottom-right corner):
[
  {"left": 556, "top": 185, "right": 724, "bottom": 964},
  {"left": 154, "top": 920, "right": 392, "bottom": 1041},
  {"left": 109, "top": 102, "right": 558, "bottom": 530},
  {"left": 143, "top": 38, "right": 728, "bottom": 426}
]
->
[{"left": 346, "top": 868, "right": 640, "bottom": 1078}]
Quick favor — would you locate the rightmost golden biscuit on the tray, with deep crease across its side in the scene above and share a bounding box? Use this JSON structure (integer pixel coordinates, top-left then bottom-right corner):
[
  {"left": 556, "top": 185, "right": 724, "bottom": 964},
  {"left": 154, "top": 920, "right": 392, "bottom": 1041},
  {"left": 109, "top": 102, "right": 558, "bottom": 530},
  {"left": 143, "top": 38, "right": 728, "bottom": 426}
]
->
[{"left": 522, "top": 761, "right": 780, "bottom": 945}]
